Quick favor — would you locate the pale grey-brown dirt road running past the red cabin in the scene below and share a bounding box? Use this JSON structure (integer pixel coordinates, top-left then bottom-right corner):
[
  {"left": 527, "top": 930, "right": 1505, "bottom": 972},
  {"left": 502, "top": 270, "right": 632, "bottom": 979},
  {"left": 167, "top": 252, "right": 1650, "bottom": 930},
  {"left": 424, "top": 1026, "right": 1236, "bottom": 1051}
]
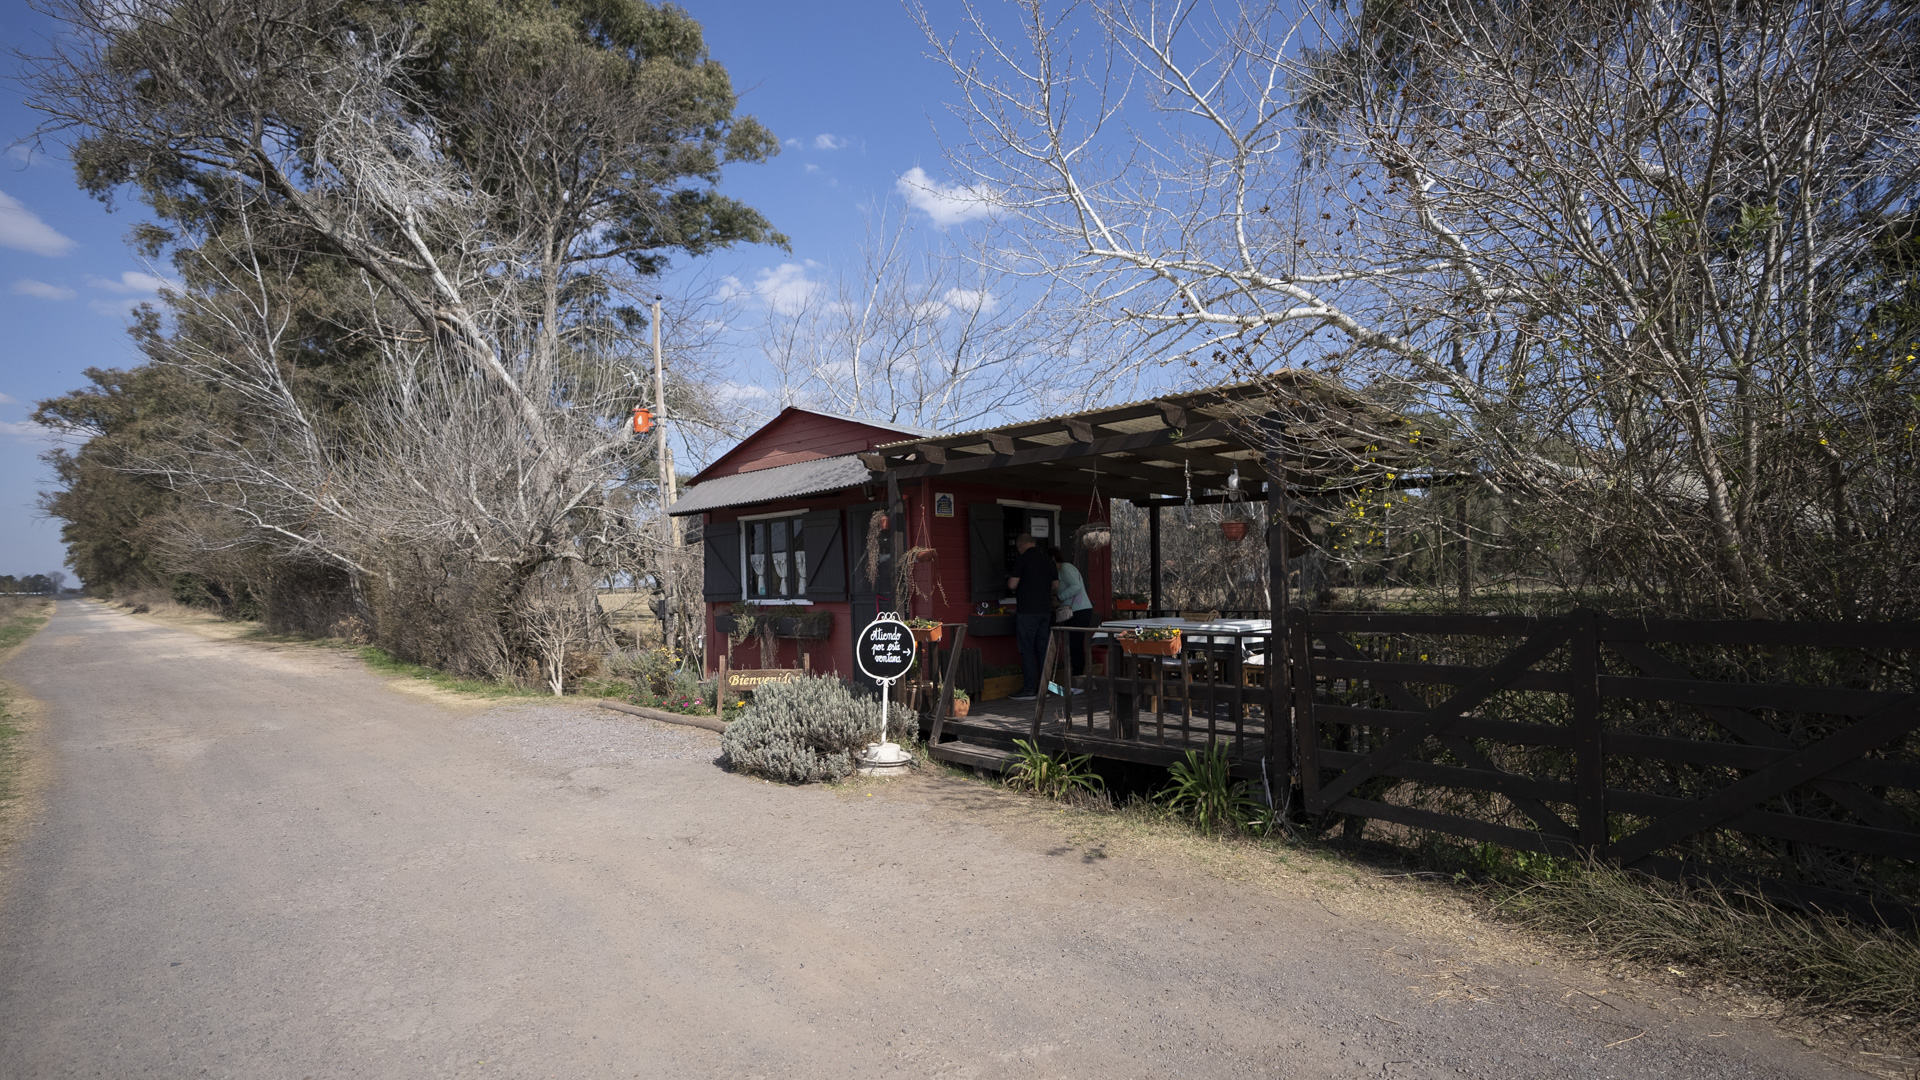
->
[{"left": 0, "top": 601, "right": 1853, "bottom": 1080}]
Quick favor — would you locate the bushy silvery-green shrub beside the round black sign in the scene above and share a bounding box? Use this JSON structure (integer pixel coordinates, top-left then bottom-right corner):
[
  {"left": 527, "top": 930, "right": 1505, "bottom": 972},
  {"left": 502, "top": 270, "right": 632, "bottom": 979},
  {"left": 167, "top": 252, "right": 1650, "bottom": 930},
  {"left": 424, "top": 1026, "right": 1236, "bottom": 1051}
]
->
[{"left": 720, "top": 676, "right": 879, "bottom": 784}]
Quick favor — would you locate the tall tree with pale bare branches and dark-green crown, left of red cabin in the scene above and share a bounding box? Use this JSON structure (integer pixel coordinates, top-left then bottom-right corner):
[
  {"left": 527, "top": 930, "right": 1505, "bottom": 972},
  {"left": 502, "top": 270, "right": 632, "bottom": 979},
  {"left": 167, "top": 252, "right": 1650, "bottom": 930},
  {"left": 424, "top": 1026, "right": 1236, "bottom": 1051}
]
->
[{"left": 22, "top": 0, "right": 781, "bottom": 678}]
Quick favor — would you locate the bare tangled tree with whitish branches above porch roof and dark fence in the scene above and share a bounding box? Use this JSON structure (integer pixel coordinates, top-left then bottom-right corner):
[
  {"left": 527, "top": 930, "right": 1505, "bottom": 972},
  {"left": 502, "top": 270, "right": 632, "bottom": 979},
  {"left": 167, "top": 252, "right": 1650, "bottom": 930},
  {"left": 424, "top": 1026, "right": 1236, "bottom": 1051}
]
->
[{"left": 922, "top": 0, "right": 1920, "bottom": 615}]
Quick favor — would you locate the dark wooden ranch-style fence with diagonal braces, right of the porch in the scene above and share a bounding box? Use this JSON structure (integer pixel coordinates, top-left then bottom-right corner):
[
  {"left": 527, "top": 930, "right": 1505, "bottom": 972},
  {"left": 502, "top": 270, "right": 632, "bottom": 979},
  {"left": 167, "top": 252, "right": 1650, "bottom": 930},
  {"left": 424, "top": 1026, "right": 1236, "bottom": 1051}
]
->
[{"left": 1288, "top": 611, "right": 1920, "bottom": 919}]
